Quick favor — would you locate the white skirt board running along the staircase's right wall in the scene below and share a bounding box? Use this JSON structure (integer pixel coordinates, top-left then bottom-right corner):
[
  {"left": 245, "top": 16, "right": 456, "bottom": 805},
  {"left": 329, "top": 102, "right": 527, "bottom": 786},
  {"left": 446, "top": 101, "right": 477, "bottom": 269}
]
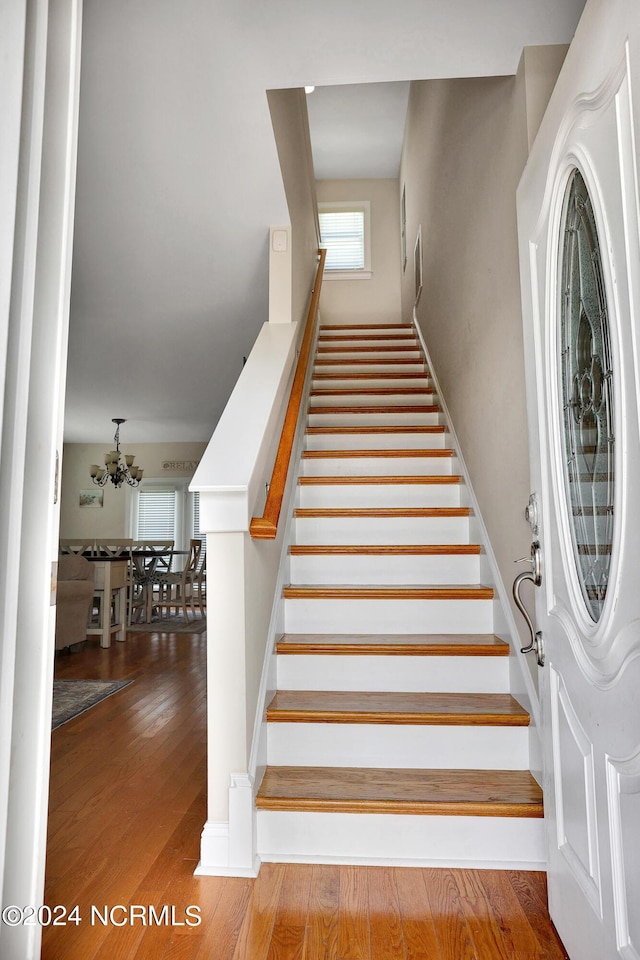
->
[{"left": 412, "top": 310, "right": 542, "bottom": 783}]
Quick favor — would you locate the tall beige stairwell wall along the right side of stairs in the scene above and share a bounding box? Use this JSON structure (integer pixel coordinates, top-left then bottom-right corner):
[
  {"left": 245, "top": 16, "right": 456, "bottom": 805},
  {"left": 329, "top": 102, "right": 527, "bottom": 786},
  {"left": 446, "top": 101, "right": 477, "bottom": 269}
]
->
[{"left": 397, "top": 48, "right": 564, "bottom": 676}]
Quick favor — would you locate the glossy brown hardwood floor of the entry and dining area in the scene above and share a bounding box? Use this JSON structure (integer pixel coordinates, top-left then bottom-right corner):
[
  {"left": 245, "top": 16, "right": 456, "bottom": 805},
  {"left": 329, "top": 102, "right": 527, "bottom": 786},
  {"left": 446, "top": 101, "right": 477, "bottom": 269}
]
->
[{"left": 42, "top": 633, "right": 567, "bottom": 960}]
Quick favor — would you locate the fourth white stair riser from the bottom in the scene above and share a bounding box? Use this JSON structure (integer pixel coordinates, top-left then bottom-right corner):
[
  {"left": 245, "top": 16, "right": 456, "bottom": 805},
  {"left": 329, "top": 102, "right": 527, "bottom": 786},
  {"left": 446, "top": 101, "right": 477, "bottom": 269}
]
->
[{"left": 284, "top": 600, "right": 493, "bottom": 634}]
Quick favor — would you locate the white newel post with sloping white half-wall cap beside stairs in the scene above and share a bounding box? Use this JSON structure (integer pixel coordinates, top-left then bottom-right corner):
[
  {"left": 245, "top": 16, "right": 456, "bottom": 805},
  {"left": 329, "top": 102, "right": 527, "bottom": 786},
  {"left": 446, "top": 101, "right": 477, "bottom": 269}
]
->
[{"left": 190, "top": 323, "right": 298, "bottom": 876}]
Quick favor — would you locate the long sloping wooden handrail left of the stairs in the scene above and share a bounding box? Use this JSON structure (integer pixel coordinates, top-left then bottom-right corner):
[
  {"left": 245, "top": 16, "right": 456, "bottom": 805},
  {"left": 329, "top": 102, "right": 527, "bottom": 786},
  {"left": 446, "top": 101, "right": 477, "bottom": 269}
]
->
[{"left": 249, "top": 250, "right": 327, "bottom": 540}]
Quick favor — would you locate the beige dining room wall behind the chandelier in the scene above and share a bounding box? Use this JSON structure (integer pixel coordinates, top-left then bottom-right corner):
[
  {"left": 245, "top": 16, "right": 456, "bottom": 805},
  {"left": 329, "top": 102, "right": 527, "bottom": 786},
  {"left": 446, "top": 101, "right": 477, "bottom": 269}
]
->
[{"left": 60, "top": 443, "right": 206, "bottom": 538}]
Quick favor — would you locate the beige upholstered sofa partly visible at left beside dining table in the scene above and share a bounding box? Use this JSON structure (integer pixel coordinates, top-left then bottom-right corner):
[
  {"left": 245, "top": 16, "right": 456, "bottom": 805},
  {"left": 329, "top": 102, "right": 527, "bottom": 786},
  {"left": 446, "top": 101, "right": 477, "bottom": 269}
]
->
[{"left": 56, "top": 554, "right": 94, "bottom": 653}]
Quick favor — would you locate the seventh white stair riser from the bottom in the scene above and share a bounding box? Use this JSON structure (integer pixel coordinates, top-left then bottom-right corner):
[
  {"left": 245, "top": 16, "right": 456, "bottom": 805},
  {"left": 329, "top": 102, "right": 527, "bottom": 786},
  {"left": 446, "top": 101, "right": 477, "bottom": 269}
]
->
[{"left": 300, "top": 483, "right": 460, "bottom": 508}]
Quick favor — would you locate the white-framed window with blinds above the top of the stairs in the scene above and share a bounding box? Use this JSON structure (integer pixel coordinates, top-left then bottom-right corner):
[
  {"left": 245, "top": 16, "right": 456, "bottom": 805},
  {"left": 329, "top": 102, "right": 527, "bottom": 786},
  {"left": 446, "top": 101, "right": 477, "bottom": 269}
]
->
[{"left": 318, "top": 200, "right": 371, "bottom": 280}]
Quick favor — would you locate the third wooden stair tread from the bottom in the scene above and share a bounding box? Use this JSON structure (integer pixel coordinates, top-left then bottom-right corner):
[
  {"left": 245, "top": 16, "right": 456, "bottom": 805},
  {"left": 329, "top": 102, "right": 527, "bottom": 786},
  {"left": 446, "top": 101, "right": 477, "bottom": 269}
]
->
[{"left": 276, "top": 633, "right": 510, "bottom": 657}]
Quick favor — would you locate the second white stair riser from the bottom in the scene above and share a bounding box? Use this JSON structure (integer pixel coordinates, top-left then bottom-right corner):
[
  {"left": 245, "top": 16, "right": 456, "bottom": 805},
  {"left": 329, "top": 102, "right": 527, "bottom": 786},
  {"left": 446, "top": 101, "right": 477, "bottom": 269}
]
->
[{"left": 267, "top": 722, "right": 529, "bottom": 770}]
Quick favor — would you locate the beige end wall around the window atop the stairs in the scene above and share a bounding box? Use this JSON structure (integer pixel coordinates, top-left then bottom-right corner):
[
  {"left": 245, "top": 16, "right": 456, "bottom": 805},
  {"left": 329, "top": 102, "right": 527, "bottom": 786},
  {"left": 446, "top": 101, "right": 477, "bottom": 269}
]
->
[{"left": 317, "top": 180, "right": 400, "bottom": 323}]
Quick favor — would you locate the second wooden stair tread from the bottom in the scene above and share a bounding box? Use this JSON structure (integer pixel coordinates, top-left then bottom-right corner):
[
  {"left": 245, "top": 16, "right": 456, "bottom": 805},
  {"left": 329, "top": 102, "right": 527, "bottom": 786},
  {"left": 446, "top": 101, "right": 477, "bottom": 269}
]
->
[{"left": 267, "top": 690, "right": 529, "bottom": 727}]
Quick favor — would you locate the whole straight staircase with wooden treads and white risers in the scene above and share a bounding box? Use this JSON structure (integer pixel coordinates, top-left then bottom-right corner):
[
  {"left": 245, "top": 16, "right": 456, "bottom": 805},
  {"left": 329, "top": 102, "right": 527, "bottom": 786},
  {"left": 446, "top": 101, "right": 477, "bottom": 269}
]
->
[{"left": 256, "top": 325, "right": 544, "bottom": 868}]
